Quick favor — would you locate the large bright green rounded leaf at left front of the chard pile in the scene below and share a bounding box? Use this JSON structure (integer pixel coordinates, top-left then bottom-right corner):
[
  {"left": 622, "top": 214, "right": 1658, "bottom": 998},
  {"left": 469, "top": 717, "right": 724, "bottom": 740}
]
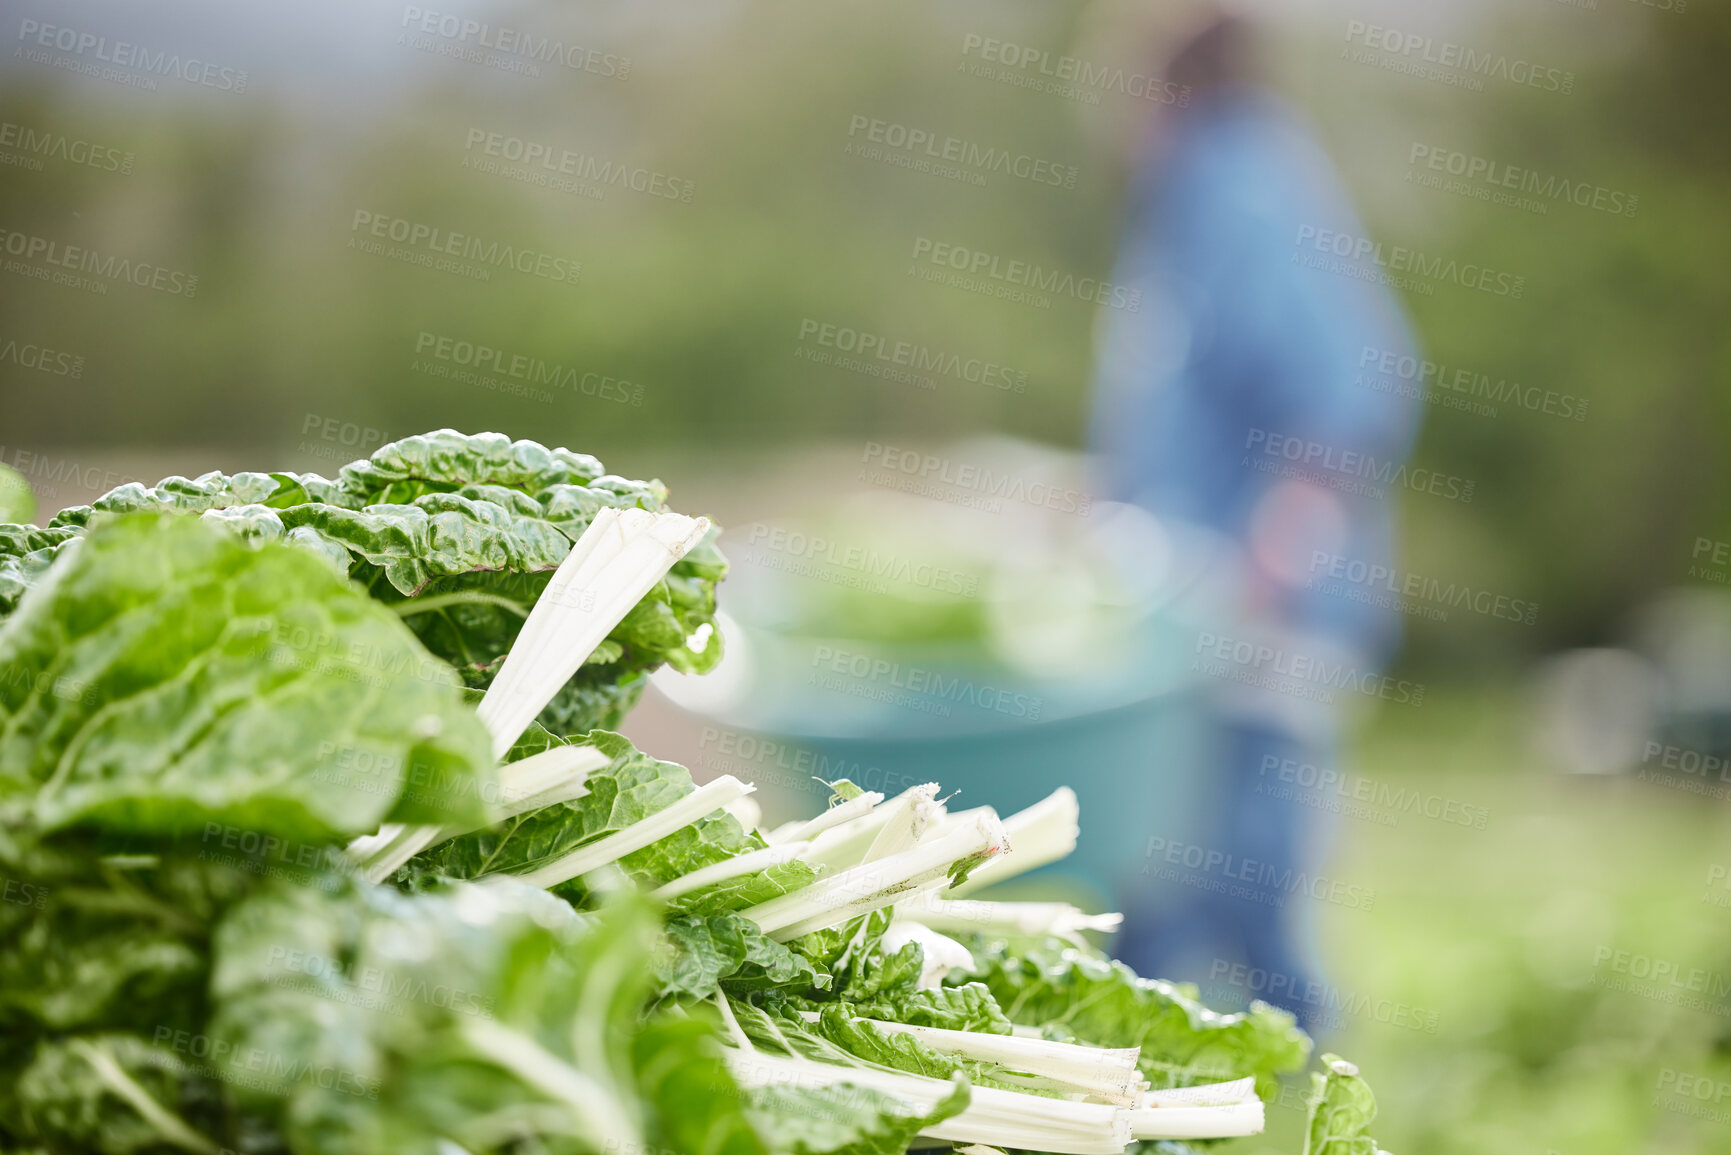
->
[{"left": 0, "top": 514, "right": 492, "bottom": 842}]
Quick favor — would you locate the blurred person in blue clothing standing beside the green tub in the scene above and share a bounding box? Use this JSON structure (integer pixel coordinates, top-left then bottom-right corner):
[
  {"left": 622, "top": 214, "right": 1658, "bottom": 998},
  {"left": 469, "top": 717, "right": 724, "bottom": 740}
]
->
[{"left": 1091, "top": 12, "right": 1421, "bottom": 1025}]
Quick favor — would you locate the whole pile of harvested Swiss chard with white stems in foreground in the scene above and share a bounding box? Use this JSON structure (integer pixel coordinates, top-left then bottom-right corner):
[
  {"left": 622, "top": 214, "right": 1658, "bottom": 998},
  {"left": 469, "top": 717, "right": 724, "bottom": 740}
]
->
[{"left": 0, "top": 431, "right": 1405, "bottom": 1155}]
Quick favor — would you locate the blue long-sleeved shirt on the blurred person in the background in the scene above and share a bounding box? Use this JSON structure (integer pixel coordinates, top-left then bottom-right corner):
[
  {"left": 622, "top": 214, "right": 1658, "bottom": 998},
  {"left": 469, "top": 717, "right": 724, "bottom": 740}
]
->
[{"left": 1091, "top": 95, "right": 1438, "bottom": 663}]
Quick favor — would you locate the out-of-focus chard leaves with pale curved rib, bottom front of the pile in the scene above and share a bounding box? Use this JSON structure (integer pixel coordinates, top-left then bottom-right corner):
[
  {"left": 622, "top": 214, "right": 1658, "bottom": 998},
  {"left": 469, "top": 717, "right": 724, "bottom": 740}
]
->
[{"left": 211, "top": 883, "right": 755, "bottom": 1155}]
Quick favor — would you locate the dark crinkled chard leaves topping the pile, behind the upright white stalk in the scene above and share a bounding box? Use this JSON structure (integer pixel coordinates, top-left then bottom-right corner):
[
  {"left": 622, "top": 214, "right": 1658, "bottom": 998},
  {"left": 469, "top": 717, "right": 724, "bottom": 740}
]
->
[{"left": 0, "top": 429, "right": 727, "bottom": 734}]
